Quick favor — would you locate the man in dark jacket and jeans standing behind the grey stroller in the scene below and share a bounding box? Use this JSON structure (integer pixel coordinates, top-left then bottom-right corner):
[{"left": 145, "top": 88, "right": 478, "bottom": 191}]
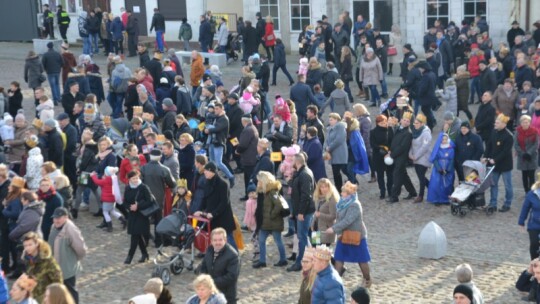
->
[{"left": 482, "top": 113, "right": 514, "bottom": 212}]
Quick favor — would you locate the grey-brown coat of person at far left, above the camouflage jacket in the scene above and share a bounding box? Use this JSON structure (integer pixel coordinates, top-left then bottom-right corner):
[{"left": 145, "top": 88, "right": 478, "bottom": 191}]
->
[{"left": 9, "top": 201, "right": 45, "bottom": 242}]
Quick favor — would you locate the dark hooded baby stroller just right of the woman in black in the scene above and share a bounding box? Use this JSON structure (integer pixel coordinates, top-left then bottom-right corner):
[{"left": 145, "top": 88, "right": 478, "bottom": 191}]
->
[{"left": 152, "top": 208, "right": 204, "bottom": 285}]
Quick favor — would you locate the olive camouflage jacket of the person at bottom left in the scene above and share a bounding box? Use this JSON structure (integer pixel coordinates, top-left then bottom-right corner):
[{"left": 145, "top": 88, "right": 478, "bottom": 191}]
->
[{"left": 23, "top": 241, "right": 63, "bottom": 303}]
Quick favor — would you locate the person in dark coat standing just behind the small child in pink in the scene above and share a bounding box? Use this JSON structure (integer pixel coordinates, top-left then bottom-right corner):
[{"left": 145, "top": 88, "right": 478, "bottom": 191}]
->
[{"left": 235, "top": 114, "right": 260, "bottom": 201}]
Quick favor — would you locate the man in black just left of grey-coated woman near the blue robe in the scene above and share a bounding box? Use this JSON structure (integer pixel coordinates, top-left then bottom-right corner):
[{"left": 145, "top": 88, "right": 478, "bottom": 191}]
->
[{"left": 386, "top": 112, "right": 417, "bottom": 203}]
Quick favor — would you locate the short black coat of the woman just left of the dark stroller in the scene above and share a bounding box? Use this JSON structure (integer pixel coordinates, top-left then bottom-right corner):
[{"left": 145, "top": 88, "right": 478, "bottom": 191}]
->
[{"left": 124, "top": 183, "right": 152, "bottom": 236}]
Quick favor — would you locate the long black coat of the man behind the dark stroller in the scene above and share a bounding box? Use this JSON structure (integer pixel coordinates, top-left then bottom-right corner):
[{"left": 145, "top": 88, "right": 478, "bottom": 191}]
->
[{"left": 201, "top": 174, "right": 236, "bottom": 233}]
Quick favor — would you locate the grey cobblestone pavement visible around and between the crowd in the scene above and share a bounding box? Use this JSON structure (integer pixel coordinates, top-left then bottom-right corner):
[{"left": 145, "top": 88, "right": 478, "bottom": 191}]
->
[{"left": 0, "top": 43, "right": 529, "bottom": 304}]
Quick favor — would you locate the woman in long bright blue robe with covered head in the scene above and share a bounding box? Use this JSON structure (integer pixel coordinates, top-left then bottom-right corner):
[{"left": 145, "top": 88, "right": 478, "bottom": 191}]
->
[{"left": 427, "top": 132, "right": 455, "bottom": 204}]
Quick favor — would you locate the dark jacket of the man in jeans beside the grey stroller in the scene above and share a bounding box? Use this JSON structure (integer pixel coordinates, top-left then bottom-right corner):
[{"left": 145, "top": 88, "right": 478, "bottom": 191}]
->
[{"left": 485, "top": 128, "right": 514, "bottom": 172}]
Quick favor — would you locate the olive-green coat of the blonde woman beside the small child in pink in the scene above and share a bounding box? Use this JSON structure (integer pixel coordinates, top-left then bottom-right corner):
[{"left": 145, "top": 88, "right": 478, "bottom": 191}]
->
[{"left": 261, "top": 181, "right": 284, "bottom": 232}]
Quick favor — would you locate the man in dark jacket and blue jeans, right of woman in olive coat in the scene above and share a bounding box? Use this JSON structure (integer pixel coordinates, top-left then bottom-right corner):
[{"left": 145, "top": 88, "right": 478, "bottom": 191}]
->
[{"left": 287, "top": 153, "right": 315, "bottom": 271}]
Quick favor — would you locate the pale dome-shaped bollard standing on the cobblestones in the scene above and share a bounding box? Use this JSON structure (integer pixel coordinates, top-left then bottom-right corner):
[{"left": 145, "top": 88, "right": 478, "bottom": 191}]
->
[{"left": 417, "top": 221, "right": 447, "bottom": 260}]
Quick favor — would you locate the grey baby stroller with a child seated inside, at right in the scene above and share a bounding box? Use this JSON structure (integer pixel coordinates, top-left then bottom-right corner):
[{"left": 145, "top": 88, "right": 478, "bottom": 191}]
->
[{"left": 450, "top": 160, "right": 495, "bottom": 216}]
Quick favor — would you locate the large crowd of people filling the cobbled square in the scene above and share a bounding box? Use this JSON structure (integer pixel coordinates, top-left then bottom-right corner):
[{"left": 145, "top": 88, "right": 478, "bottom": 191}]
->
[{"left": 0, "top": 7, "right": 540, "bottom": 304}]
